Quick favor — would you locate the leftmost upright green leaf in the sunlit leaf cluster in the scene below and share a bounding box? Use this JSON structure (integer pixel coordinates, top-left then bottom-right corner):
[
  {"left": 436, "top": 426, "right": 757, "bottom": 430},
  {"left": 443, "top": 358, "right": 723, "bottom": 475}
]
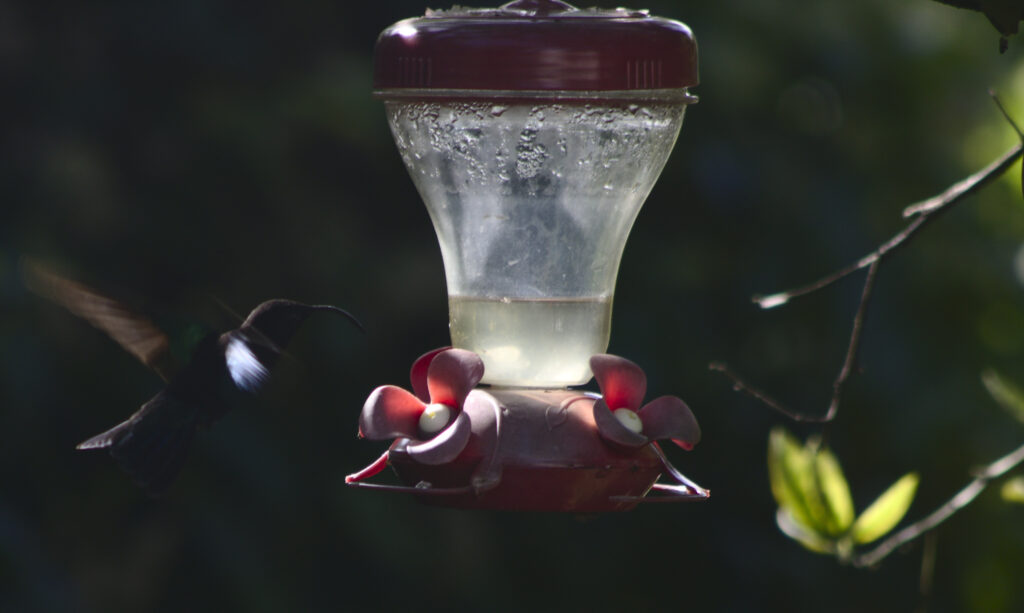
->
[{"left": 768, "top": 428, "right": 827, "bottom": 534}]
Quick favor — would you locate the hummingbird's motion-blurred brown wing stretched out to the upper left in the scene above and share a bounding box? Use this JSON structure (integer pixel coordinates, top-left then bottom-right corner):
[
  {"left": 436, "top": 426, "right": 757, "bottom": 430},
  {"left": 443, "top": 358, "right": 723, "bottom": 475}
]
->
[{"left": 22, "top": 260, "right": 176, "bottom": 381}]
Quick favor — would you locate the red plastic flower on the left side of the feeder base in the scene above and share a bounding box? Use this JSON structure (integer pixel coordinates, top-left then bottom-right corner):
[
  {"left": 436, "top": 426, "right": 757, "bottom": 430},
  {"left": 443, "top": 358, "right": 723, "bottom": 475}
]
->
[{"left": 359, "top": 347, "right": 483, "bottom": 465}]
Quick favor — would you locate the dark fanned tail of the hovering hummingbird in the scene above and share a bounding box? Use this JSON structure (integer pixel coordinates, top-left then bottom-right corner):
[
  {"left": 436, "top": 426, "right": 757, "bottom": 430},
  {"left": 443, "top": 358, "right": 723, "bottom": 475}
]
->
[{"left": 76, "top": 395, "right": 198, "bottom": 496}]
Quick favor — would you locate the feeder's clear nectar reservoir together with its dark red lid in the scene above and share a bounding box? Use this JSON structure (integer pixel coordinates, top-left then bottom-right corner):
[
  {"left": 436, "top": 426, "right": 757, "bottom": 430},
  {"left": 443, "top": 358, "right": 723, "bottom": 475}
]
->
[{"left": 375, "top": 0, "right": 696, "bottom": 388}]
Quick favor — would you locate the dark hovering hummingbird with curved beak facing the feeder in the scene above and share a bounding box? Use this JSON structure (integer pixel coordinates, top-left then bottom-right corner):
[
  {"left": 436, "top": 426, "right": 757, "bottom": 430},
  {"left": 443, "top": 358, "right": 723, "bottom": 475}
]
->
[{"left": 23, "top": 261, "right": 362, "bottom": 496}]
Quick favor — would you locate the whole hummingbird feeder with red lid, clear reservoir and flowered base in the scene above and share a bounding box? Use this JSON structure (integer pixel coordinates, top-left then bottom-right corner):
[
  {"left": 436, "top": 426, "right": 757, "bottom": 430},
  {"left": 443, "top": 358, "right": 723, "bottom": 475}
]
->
[{"left": 346, "top": 0, "right": 709, "bottom": 512}]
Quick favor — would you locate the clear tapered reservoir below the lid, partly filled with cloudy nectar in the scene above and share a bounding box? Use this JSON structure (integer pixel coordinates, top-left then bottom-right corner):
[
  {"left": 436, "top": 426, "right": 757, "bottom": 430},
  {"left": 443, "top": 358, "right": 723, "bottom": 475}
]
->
[{"left": 386, "top": 99, "right": 685, "bottom": 387}]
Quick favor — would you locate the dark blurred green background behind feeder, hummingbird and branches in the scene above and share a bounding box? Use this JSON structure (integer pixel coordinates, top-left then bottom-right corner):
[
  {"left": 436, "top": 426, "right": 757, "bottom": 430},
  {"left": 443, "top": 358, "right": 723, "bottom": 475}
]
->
[{"left": 6, "top": 0, "right": 1024, "bottom": 612}]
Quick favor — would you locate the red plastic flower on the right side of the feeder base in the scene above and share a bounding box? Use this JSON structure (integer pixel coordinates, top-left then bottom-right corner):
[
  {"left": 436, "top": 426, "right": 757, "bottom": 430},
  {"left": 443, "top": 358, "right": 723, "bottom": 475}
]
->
[{"left": 590, "top": 353, "right": 700, "bottom": 449}]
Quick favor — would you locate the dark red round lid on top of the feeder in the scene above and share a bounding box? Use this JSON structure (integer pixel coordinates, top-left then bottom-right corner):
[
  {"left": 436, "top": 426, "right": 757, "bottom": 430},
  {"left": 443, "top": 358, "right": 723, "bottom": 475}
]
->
[{"left": 374, "top": 0, "right": 698, "bottom": 98}]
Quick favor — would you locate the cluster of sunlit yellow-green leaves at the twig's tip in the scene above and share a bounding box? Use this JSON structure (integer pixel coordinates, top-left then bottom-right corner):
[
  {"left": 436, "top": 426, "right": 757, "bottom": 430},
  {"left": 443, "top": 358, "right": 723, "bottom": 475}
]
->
[{"left": 768, "top": 427, "right": 919, "bottom": 561}]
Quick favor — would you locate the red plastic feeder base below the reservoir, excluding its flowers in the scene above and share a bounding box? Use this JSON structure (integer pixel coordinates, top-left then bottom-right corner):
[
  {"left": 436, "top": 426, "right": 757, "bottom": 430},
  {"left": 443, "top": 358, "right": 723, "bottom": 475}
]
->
[{"left": 352, "top": 389, "right": 708, "bottom": 513}]
